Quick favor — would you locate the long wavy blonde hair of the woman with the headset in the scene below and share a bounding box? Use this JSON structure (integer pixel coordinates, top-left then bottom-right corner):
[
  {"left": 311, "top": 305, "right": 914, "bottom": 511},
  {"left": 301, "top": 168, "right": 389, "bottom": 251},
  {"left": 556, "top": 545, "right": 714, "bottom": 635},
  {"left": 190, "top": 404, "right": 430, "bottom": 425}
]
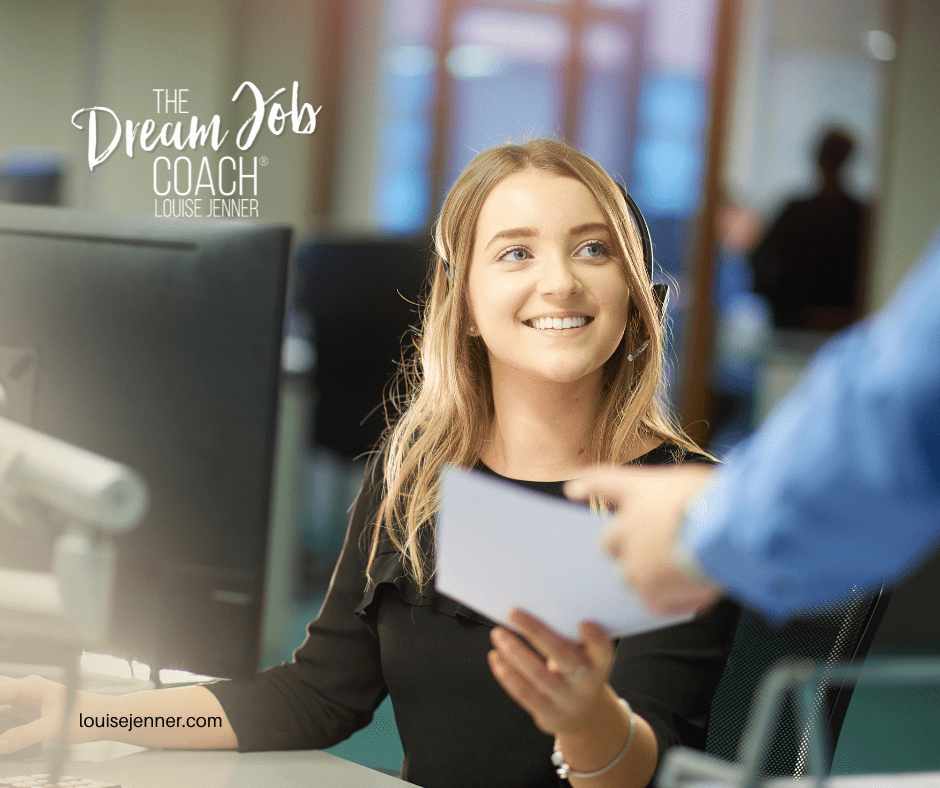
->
[{"left": 365, "top": 139, "right": 698, "bottom": 589}]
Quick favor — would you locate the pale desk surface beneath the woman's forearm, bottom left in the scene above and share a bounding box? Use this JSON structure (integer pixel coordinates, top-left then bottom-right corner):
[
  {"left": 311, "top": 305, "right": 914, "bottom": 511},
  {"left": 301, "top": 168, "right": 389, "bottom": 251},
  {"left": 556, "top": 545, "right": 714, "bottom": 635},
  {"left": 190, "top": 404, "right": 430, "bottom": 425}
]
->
[{"left": 0, "top": 742, "right": 411, "bottom": 788}]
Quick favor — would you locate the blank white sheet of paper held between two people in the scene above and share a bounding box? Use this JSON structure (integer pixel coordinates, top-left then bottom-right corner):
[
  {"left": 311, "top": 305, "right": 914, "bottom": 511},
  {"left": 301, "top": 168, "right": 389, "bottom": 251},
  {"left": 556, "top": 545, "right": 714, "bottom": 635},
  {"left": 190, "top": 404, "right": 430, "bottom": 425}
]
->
[{"left": 436, "top": 466, "right": 691, "bottom": 640}]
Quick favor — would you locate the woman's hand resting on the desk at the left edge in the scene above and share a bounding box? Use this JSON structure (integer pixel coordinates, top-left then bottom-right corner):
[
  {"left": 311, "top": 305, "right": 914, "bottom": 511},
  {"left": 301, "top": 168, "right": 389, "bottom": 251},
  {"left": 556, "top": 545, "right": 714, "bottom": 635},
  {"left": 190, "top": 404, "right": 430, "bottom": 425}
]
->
[{"left": 0, "top": 676, "right": 84, "bottom": 754}]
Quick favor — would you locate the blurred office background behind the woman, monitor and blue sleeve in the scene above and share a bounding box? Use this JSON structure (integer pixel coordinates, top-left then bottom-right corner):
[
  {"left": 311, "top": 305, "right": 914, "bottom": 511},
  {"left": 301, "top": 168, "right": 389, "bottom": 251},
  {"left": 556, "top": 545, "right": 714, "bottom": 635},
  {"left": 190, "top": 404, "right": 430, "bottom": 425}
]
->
[{"left": 0, "top": 0, "right": 940, "bottom": 768}]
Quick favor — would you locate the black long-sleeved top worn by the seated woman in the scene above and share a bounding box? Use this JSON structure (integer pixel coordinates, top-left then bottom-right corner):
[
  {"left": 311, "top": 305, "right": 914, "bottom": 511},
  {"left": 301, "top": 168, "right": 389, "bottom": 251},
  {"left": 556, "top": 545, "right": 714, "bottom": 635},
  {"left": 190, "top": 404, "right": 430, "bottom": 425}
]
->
[{"left": 207, "top": 446, "right": 739, "bottom": 788}]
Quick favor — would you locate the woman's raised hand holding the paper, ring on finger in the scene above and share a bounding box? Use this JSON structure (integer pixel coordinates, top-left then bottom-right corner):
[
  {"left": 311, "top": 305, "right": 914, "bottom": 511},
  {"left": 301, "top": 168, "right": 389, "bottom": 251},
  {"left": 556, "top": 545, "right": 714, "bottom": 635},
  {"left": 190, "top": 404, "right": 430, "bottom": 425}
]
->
[{"left": 488, "top": 610, "right": 614, "bottom": 735}]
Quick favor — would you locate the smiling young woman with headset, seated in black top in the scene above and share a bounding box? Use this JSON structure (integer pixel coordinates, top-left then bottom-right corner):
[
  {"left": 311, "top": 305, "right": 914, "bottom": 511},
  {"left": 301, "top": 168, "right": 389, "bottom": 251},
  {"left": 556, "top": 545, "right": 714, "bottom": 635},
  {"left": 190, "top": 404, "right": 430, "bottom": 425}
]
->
[{"left": 0, "top": 140, "right": 737, "bottom": 788}]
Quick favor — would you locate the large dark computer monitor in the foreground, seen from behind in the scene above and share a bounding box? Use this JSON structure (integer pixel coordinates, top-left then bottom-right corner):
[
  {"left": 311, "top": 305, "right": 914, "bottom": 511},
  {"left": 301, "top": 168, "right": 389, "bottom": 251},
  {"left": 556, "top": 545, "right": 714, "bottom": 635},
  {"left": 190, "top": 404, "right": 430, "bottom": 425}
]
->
[{"left": 0, "top": 206, "right": 290, "bottom": 677}]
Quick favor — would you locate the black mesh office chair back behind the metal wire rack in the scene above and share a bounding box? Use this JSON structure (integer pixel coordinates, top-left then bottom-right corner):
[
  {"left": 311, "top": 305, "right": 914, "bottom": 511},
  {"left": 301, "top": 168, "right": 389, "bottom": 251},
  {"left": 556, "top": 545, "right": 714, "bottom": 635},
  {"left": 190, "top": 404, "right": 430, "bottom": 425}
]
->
[{"left": 705, "top": 589, "right": 890, "bottom": 776}]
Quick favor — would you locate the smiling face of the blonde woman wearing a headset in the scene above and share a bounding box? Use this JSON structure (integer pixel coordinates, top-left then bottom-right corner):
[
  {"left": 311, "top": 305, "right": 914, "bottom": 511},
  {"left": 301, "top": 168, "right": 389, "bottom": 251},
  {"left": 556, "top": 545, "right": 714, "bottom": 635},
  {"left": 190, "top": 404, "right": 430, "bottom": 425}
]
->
[{"left": 467, "top": 169, "right": 629, "bottom": 391}]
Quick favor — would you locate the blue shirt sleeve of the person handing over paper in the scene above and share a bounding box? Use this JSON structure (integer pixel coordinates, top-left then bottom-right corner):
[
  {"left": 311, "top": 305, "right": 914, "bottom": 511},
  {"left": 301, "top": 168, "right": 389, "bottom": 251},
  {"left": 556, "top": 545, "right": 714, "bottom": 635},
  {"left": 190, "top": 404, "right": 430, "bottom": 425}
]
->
[{"left": 682, "top": 228, "right": 940, "bottom": 618}]
